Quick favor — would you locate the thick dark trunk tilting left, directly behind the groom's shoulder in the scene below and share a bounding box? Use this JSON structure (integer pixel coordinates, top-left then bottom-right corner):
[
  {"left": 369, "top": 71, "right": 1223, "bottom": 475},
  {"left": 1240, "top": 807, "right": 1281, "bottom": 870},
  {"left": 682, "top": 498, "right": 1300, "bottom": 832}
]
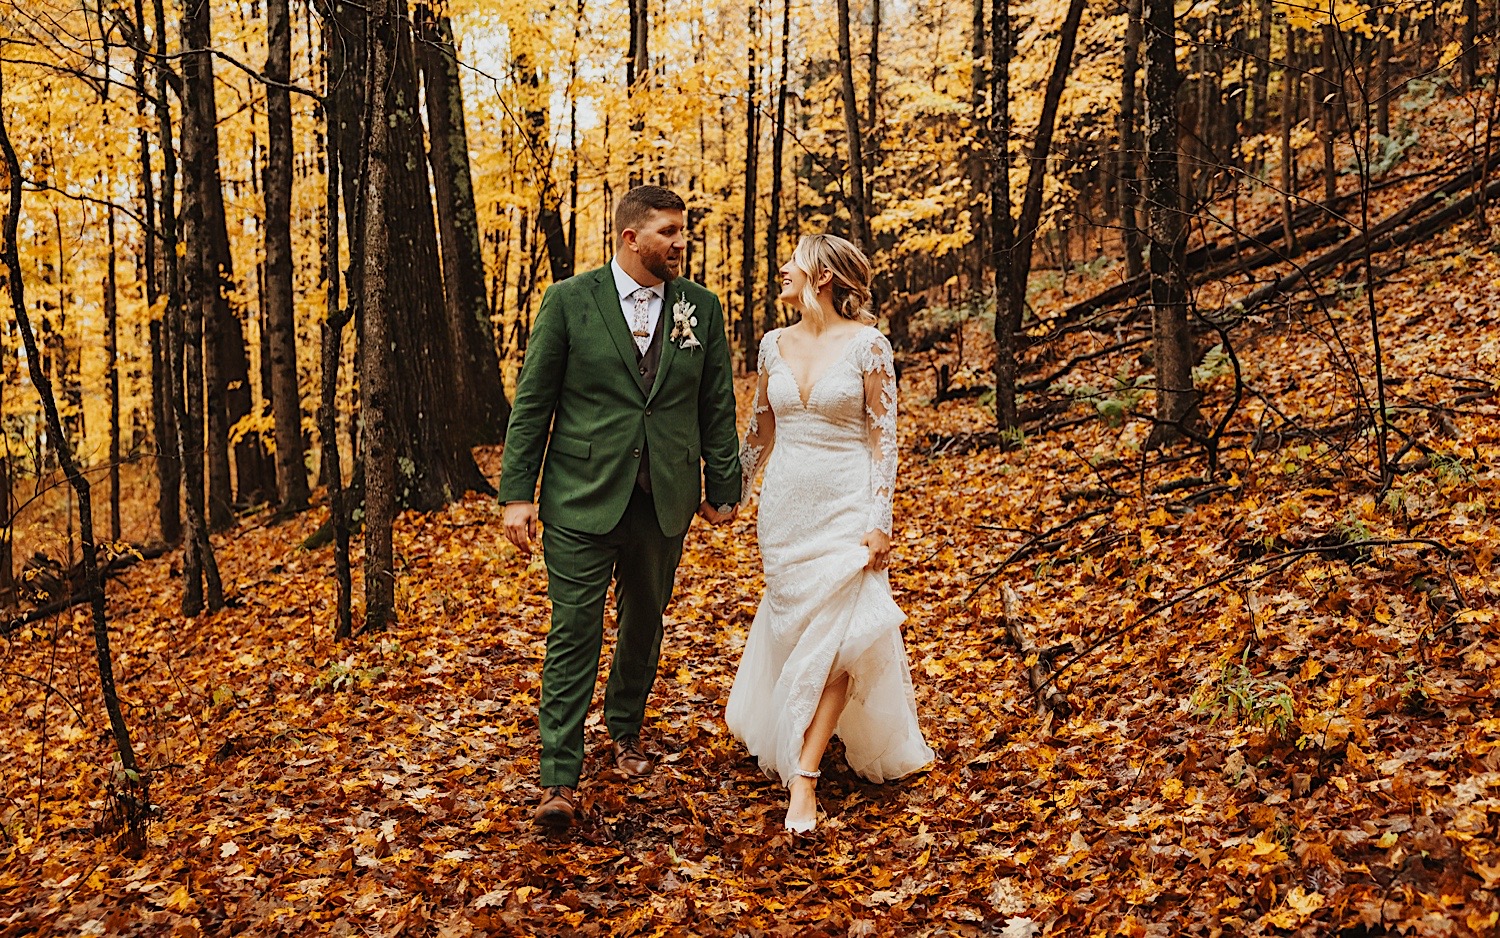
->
[{"left": 417, "top": 8, "right": 513, "bottom": 444}]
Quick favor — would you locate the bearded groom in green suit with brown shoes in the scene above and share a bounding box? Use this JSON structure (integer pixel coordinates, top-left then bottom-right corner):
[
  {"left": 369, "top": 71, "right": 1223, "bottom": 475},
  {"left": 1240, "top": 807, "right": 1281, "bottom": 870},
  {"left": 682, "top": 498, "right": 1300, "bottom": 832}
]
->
[{"left": 500, "top": 186, "right": 740, "bottom": 827}]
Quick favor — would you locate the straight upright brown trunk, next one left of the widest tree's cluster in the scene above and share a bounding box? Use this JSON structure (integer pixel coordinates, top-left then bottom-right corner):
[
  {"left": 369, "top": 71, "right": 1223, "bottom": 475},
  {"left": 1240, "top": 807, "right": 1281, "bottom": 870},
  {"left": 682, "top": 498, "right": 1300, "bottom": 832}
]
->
[{"left": 264, "top": 0, "right": 308, "bottom": 515}]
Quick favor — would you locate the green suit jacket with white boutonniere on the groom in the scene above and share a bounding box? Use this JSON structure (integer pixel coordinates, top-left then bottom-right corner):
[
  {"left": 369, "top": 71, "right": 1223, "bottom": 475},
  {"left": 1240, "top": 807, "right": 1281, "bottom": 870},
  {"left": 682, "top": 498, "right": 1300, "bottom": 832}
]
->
[{"left": 500, "top": 264, "right": 740, "bottom": 537}]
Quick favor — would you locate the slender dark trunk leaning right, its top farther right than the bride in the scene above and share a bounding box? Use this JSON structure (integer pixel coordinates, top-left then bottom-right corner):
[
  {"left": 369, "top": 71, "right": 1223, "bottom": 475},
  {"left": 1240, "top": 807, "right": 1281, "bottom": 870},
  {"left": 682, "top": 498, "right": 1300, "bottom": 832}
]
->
[{"left": 995, "top": 0, "right": 1085, "bottom": 429}]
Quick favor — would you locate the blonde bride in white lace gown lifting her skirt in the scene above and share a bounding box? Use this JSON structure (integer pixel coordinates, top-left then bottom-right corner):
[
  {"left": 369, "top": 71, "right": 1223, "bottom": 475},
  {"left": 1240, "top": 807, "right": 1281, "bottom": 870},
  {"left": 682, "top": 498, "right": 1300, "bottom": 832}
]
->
[{"left": 725, "top": 234, "right": 933, "bottom": 831}]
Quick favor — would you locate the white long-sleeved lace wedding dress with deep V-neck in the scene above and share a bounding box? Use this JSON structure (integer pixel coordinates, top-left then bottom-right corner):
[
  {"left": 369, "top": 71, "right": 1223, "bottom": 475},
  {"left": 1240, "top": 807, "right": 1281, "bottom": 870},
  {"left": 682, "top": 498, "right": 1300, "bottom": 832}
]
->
[{"left": 725, "top": 326, "right": 933, "bottom": 785}]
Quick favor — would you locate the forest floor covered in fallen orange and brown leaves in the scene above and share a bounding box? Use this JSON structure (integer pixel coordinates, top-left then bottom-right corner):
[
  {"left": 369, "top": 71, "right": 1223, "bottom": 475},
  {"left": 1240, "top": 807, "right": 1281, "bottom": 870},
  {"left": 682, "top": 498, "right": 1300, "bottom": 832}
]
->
[{"left": 0, "top": 171, "right": 1500, "bottom": 938}]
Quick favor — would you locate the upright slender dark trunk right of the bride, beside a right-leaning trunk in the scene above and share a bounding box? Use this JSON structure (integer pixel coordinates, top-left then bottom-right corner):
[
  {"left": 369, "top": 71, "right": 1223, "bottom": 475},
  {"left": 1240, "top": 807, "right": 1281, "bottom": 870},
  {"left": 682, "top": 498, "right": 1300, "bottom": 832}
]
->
[{"left": 989, "top": 0, "right": 1026, "bottom": 428}]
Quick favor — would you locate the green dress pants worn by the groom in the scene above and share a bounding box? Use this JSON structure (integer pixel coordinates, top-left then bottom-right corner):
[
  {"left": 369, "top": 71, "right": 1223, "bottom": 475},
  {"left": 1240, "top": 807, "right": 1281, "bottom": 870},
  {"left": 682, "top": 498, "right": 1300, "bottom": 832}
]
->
[{"left": 540, "top": 488, "right": 683, "bottom": 788}]
